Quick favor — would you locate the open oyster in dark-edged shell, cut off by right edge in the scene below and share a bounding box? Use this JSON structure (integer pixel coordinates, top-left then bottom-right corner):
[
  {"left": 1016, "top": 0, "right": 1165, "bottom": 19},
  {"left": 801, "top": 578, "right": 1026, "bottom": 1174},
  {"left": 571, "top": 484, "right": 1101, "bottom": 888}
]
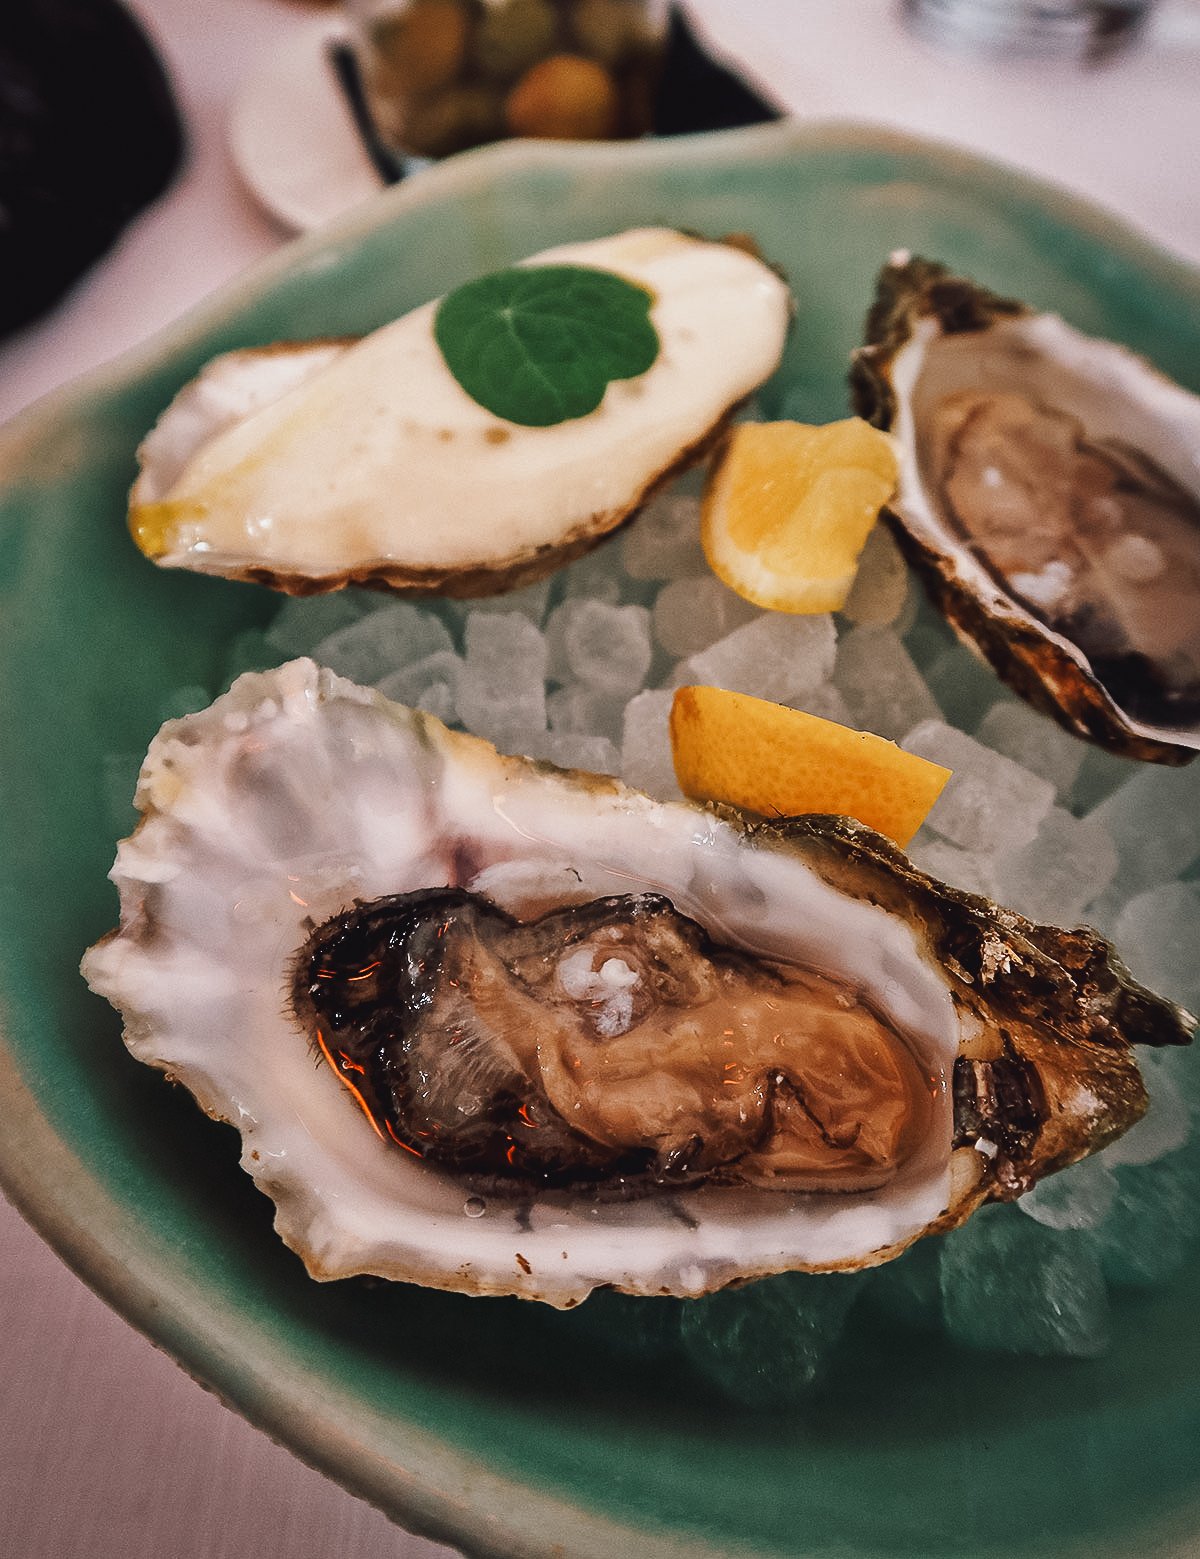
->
[{"left": 851, "top": 256, "right": 1200, "bottom": 764}]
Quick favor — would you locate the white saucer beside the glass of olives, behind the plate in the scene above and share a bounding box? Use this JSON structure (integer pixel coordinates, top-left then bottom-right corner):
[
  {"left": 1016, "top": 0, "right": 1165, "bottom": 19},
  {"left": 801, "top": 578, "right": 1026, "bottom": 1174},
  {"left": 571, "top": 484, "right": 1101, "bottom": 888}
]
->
[{"left": 229, "top": 17, "right": 383, "bottom": 232}]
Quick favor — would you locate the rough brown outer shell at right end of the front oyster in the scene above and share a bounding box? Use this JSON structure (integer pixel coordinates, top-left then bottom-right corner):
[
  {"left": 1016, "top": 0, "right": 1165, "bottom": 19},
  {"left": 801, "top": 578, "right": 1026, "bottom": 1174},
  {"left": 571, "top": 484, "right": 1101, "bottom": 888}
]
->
[{"left": 785, "top": 817, "right": 1194, "bottom": 1203}]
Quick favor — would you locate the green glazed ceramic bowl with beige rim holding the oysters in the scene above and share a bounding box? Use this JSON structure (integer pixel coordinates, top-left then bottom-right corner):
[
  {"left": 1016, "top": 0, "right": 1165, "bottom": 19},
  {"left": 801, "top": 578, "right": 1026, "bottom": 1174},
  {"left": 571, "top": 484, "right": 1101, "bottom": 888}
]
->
[{"left": 0, "top": 126, "right": 1200, "bottom": 1559}]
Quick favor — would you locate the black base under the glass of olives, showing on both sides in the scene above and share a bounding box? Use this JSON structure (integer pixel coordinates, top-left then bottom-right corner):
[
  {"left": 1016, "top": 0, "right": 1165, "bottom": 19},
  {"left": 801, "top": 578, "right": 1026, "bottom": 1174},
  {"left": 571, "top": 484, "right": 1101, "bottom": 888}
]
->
[{"left": 327, "top": 0, "right": 784, "bottom": 184}]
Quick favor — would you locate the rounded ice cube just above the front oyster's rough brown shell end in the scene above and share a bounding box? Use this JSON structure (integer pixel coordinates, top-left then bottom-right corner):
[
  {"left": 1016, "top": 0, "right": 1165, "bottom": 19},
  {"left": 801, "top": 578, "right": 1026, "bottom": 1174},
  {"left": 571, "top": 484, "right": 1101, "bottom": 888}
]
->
[{"left": 996, "top": 806, "right": 1117, "bottom": 926}]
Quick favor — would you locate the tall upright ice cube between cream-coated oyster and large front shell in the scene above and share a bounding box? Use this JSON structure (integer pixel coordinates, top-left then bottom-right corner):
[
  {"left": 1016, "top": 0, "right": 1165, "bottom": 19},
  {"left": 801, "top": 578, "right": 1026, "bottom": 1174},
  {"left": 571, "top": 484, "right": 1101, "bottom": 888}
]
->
[{"left": 455, "top": 611, "right": 545, "bottom": 751}]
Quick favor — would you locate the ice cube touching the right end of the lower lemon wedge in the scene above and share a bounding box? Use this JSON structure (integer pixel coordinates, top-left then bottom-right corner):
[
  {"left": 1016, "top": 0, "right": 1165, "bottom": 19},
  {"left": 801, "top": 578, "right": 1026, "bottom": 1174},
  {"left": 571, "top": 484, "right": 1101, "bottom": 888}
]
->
[{"left": 901, "top": 720, "right": 1054, "bottom": 853}]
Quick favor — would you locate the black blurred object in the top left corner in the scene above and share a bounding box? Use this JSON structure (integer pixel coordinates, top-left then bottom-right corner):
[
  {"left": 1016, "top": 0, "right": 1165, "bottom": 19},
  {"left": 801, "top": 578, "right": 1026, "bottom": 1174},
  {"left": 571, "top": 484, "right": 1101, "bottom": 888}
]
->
[{"left": 0, "top": 0, "right": 184, "bottom": 335}]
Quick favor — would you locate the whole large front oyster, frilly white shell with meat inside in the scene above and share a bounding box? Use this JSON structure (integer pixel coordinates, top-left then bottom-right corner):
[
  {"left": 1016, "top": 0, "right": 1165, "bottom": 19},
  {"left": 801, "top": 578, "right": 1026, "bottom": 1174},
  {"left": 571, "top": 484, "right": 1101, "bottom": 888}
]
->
[{"left": 84, "top": 661, "right": 1188, "bottom": 1305}]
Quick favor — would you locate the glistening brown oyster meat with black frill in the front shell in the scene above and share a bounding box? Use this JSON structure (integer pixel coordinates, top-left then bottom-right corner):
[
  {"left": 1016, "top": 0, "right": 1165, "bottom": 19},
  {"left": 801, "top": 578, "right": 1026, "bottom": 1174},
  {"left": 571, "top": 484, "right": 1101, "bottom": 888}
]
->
[{"left": 293, "top": 889, "right": 938, "bottom": 1196}]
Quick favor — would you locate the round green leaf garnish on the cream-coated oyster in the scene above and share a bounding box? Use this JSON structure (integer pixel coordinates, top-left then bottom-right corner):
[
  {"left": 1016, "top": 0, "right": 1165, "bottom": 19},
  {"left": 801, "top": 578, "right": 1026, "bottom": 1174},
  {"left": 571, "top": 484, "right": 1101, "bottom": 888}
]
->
[{"left": 433, "top": 265, "right": 659, "bottom": 427}]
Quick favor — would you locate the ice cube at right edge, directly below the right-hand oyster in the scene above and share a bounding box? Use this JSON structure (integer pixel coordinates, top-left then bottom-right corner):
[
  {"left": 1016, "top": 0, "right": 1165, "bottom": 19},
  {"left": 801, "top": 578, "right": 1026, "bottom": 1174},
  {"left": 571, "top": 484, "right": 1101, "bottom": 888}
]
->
[{"left": 1089, "top": 762, "right": 1200, "bottom": 895}]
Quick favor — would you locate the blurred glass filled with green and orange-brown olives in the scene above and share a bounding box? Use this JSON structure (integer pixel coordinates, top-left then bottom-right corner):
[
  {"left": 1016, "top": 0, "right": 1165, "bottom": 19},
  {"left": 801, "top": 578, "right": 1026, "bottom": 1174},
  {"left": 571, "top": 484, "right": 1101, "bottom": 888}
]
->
[{"left": 346, "top": 0, "right": 669, "bottom": 157}]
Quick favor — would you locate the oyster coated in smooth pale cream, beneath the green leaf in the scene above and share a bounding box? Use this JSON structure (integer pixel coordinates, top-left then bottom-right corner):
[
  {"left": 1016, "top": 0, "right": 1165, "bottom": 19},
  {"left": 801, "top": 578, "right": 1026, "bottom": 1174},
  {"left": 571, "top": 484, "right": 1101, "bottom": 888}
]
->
[{"left": 129, "top": 228, "right": 792, "bottom": 596}]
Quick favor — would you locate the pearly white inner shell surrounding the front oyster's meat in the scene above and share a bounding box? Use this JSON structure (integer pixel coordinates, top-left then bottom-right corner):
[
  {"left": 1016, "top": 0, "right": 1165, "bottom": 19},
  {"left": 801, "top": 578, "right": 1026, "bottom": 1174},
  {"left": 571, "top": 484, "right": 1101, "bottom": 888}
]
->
[{"left": 84, "top": 661, "right": 958, "bottom": 1305}]
